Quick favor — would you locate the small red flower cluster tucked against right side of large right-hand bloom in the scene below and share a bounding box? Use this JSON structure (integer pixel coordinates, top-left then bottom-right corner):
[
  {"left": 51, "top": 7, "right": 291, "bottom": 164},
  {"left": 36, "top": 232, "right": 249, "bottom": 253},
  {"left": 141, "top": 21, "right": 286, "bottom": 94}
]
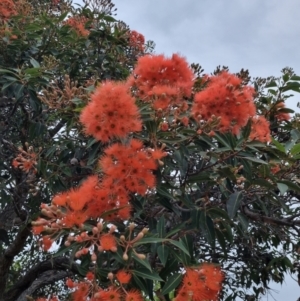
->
[{"left": 249, "top": 116, "right": 271, "bottom": 142}]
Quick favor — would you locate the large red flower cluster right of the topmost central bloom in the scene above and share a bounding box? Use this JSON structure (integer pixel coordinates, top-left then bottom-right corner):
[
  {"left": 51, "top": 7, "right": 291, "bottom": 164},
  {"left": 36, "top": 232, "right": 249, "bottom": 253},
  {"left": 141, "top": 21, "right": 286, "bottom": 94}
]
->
[{"left": 192, "top": 72, "right": 256, "bottom": 134}]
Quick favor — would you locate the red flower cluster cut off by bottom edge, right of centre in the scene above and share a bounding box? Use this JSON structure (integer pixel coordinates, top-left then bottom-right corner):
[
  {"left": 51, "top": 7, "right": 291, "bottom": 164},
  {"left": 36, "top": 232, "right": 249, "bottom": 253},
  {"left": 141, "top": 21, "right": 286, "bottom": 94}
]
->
[{"left": 175, "top": 263, "right": 224, "bottom": 301}]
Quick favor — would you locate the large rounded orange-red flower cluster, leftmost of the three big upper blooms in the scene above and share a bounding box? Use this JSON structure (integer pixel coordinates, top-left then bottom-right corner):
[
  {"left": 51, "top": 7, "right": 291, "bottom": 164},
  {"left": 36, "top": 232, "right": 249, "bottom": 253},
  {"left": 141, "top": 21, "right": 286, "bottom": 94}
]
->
[{"left": 80, "top": 81, "right": 142, "bottom": 142}]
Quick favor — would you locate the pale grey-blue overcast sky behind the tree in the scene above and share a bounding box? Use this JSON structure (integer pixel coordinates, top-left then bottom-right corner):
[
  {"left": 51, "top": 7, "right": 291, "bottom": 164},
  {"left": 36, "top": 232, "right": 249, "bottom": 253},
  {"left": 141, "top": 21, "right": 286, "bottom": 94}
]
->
[{"left": 109, "top": 0, "right": 300, "bottom": 301}]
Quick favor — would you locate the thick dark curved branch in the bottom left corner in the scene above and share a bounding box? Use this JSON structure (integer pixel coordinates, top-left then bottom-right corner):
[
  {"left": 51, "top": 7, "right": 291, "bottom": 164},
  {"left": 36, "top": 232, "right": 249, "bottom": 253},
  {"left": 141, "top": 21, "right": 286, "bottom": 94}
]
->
[{"left": 4, "top": 256, "right": 79, "bottom": 301}]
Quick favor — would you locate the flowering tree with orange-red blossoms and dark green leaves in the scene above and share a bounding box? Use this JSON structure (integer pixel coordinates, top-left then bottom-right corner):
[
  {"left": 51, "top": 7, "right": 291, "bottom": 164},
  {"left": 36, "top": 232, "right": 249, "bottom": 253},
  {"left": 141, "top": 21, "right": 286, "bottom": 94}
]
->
[{"left": 0, "top": 0, "right": 300, "bottom": 301}]
